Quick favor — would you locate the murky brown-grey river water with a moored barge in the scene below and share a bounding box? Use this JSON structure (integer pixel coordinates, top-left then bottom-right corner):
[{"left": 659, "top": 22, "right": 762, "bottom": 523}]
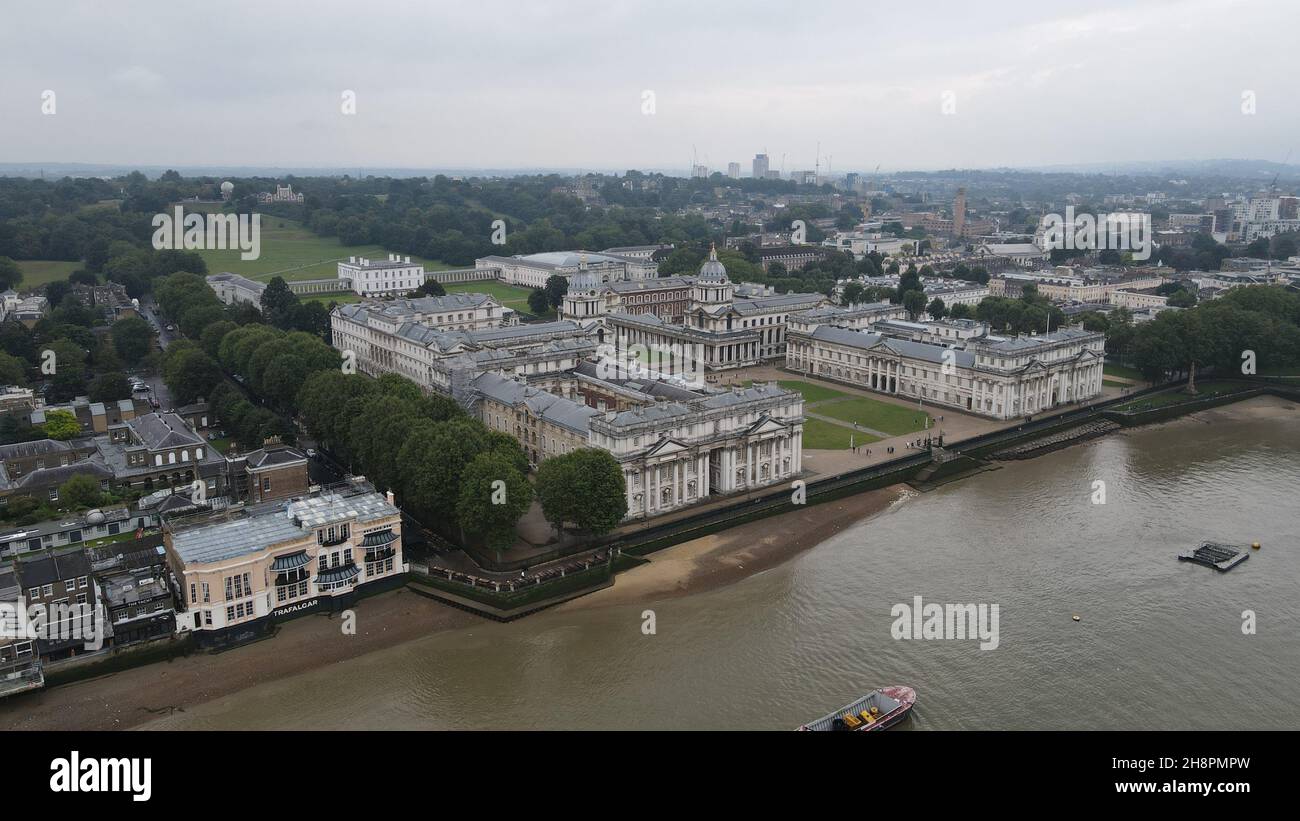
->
[{"left": 148, "top": 399, "right": 1300, "bottom": 730}]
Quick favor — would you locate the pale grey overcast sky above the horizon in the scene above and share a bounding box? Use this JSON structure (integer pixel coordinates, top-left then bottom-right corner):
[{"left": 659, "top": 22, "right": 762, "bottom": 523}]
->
[{"left": 0, "top": 0, "right": 1300, "bottom": 174}]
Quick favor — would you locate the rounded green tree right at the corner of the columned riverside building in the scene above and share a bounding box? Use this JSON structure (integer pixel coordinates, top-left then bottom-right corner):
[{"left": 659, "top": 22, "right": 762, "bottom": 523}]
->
[{"left": 536, "top": 448, "right": 628, "bottom": 535}]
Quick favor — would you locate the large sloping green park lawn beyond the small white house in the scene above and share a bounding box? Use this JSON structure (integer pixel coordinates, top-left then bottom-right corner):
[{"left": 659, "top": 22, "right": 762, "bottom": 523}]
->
[{"left": 199, "top": 214, "right": 451, "bottom": 282}]
